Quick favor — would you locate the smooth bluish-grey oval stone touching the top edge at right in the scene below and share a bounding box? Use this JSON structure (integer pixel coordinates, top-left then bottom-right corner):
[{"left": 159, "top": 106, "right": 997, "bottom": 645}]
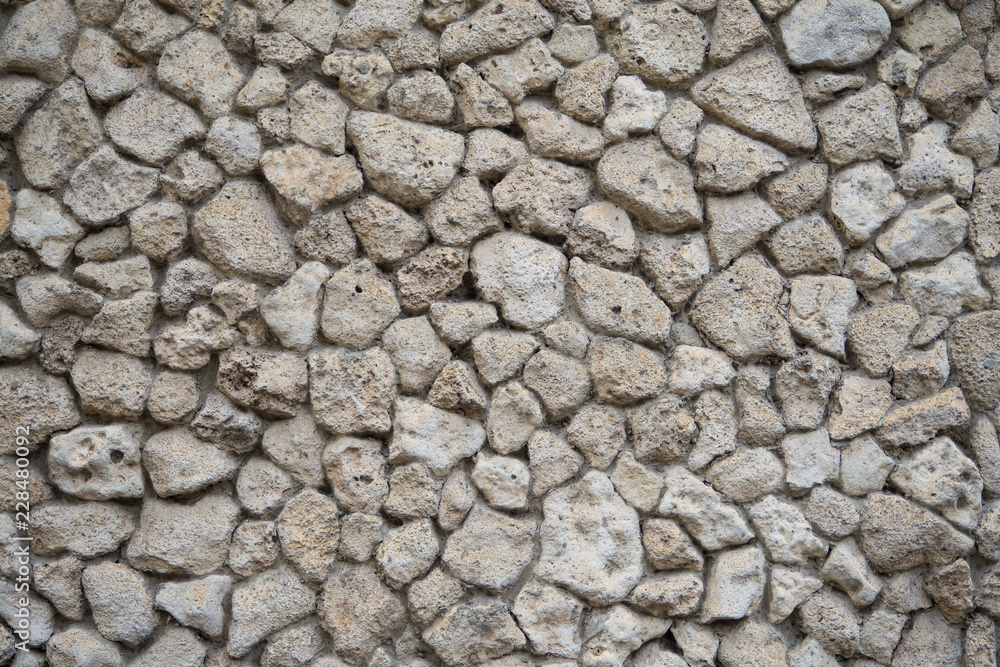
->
[{"left": 778, "top": 0, "right": 891, "bottom": 68}]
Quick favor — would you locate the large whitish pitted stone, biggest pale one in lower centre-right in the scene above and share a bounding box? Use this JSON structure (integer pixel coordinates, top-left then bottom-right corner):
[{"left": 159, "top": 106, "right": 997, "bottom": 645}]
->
[{"left": 535, "top": 472, "right": 642, "bottom": 605}]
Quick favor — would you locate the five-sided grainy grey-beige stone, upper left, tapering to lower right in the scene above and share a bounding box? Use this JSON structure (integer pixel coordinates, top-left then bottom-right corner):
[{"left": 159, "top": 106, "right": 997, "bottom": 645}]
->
[{"left": 156, "top": 30, "right": 243, "bottom": 118}]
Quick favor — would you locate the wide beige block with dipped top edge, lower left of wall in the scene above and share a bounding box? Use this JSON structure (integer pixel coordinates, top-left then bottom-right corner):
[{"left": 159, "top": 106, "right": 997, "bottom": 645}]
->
[{"left": 125, "top": 491, "right": 239, "bottom": 574}]
